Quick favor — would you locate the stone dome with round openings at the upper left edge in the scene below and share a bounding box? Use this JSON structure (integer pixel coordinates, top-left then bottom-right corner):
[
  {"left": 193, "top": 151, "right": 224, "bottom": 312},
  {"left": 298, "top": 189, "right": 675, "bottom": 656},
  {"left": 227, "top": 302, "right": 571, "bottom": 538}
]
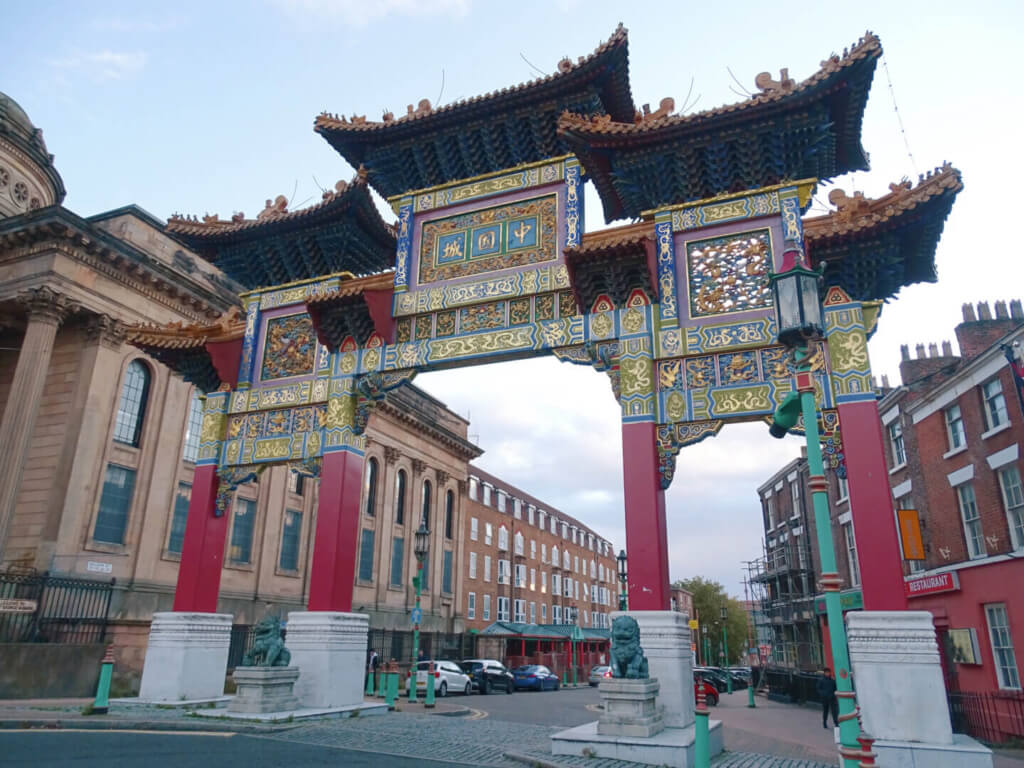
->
[{"left": 0, "top": 91, "right": 65, "bottom": 217}]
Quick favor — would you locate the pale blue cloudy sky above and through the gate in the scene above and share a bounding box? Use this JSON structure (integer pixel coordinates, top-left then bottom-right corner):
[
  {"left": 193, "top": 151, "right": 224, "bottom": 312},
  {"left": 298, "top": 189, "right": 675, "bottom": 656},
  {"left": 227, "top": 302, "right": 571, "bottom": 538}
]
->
[{"left": 0, "top": 0, "right": 1024, "bottom": 597}]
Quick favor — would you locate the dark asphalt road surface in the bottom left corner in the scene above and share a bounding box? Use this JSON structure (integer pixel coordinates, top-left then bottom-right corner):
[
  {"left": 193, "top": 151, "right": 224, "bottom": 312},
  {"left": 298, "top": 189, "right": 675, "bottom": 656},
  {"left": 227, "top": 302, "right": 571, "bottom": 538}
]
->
[{"left": 0, "top": 729, "right": 481, "bottom": 768}]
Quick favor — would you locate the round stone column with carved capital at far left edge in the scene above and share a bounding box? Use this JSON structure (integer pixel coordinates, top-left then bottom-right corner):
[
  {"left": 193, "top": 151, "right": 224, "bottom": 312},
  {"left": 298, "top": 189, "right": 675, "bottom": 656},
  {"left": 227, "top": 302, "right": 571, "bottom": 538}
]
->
[{"left": 0, "top": 286, "right": 77, "bottom": 561}]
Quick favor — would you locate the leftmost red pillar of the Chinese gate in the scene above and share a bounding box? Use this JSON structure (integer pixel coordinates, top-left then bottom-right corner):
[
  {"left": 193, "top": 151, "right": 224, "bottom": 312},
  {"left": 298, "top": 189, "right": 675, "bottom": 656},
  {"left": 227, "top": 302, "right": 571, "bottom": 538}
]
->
[{"left": 174, "top": 464, "right": 228, "bottom": 613}]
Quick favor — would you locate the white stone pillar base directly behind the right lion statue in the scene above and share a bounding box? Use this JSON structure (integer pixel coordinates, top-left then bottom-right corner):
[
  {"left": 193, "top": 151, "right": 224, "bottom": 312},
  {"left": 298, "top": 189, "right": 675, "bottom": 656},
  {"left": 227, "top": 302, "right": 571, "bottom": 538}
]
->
[{"left": 610, "top": 610, "right": 694, "bottom": 728}]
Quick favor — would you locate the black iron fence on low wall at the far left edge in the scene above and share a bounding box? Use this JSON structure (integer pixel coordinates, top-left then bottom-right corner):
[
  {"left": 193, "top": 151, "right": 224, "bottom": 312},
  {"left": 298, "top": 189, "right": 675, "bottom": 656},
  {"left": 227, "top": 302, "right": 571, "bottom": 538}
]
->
[{"left": 0, "top": 572, "right": 115, "bottom": 643}]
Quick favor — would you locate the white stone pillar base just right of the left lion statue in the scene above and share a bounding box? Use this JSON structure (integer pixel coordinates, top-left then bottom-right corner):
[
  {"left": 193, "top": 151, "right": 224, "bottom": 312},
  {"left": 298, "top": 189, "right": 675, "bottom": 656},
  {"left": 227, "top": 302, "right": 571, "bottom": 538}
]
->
[{"left": 285, "top": 610, "right": 370, "bottom": 709}]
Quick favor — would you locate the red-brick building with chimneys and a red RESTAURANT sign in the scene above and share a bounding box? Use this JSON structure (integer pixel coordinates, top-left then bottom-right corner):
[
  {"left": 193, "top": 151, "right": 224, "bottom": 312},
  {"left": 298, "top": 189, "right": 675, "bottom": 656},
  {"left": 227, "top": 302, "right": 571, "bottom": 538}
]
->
[{"left": 879, "top": 301, "right": 1024, "bottom": 691}]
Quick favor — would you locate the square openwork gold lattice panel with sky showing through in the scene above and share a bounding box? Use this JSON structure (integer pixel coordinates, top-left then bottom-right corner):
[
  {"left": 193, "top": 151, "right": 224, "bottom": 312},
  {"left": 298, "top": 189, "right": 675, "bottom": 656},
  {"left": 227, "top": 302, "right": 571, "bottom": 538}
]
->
[{"left": 686, "top": 228, "right": 772, "bottom": 317}]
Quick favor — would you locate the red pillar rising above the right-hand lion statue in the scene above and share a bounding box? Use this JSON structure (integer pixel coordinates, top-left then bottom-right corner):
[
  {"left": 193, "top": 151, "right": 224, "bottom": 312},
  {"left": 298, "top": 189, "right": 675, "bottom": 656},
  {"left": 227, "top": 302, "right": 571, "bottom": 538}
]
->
[{"left": 623, "top": 422, "right": 670, "bottom": 610}]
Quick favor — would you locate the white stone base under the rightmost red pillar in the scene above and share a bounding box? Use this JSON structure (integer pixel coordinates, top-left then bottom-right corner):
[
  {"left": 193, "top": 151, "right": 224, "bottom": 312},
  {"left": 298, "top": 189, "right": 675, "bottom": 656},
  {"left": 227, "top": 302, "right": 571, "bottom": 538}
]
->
[{"left": 846, "top": 610, "right": 992, "bottom": 768}]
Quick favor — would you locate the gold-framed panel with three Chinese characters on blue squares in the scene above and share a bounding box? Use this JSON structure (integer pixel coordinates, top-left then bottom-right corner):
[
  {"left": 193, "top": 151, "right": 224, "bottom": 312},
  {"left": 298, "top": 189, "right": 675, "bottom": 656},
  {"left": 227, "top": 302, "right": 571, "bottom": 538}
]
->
[{"left": 419, "top": 195, "right": 558, "bottom": 285}]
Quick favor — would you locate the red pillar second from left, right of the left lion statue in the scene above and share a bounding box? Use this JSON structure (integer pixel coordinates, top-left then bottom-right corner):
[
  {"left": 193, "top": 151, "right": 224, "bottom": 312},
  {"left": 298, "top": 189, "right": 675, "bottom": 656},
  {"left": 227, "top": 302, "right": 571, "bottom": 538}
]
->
[{"left": 309, "top": 451, "right": 362, "bottom": 612}]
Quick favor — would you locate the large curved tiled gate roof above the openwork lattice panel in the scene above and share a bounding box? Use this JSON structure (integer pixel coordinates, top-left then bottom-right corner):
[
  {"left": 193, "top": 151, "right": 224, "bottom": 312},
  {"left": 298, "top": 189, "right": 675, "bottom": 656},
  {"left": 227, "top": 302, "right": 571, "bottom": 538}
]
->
[{"left": 558, "top": 33, "right": 882, "bottom": 221}]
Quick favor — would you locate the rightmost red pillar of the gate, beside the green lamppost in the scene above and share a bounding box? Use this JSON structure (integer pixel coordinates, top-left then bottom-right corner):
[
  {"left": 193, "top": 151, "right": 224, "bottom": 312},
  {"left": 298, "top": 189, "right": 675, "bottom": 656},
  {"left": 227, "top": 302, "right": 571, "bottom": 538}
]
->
[{"left": 837, "top": 400, "right": 907, "bottom": 610}]
